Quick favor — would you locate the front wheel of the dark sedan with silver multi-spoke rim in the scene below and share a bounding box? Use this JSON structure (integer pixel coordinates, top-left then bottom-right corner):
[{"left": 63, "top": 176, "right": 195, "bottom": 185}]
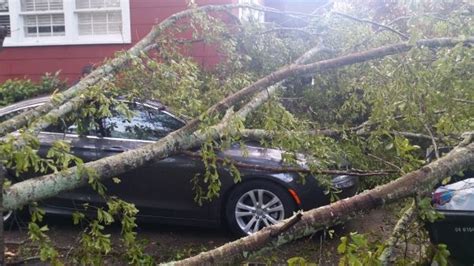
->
[{"left": 225, "top": 180, "right": 296, "bottom": 236}]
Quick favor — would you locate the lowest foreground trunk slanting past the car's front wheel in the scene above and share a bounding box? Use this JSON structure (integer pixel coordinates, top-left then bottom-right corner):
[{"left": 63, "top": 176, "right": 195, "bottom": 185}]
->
[{"left": 168, "top": 140, "right": 474, "bottom": 265}]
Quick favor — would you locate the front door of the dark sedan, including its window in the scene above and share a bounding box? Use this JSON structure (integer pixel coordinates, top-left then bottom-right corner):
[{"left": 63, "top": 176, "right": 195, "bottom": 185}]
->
[{"left": 98, "top": 104, "right": 209, "bottom": 221}]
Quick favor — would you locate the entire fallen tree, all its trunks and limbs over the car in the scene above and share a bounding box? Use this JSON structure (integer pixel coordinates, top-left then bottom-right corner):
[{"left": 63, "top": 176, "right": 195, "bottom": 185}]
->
[{"left": 0, "top": 1, "right": 474, "bottom": 264}]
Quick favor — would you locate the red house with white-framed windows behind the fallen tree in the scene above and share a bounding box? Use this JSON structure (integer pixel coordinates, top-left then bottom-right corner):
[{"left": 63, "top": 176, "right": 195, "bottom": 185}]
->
[{"left": 0, "top": 0, "right": 321, "bottom": 82}]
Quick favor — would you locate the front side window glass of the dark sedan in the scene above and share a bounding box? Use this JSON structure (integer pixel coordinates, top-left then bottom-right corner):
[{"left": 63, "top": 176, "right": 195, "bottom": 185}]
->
[{"left": 101, "top": 104, "right": 184, "bottom": 140}]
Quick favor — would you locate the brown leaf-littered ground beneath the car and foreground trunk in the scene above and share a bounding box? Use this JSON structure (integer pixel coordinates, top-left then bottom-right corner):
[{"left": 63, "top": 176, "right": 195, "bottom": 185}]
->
[{"left": 5, "top": 206, "right": 396, "bottom": 265}]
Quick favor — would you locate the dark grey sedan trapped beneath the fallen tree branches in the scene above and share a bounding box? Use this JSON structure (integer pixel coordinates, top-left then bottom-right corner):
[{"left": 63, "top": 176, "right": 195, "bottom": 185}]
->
[{"left": 0, "top": 97, "right": 358, "bottom": 235}]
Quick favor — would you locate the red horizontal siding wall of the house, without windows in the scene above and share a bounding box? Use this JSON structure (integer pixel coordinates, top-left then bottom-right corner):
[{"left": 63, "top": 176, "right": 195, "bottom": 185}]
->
[{"left": 0, "top": 0, "right": 238, "bottom": 83}]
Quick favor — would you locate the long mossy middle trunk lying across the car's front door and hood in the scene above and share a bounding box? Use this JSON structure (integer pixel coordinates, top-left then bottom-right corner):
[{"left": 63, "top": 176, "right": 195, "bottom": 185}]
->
[{"left": 3, "top": 34, "right": 474, "bottom": 209}]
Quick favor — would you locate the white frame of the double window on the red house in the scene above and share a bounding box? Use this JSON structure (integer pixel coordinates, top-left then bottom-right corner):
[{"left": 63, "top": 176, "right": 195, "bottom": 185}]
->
[{"left": 3, "top": 0, "right": 133, "bottom": 47}]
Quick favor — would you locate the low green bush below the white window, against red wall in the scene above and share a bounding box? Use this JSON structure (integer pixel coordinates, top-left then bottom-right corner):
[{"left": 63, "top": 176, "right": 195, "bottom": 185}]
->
[{"left": 0, "top": 72, "right": 66, "bottom": 107}]
